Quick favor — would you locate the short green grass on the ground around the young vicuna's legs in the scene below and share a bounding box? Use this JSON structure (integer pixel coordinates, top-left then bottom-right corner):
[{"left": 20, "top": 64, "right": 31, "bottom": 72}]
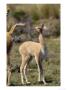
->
[{"left": 10, "top": 38, "right": 60, "bottom": 86}]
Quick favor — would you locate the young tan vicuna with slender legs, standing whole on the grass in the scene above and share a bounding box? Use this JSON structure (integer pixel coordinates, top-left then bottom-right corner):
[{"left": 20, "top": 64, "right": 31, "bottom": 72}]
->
[{"left": 19, "top": 24, "right": 46, "bottom": 84}]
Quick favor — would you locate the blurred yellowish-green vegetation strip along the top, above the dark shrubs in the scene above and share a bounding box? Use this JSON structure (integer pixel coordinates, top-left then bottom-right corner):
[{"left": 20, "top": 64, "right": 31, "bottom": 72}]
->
[{"left": 7, "top": 4, "right": 60, "bottom": 20}]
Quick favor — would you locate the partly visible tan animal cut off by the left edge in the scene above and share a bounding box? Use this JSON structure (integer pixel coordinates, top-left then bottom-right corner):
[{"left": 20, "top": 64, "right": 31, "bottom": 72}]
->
[{"left": 7, "top": 23, "right": 25, "bottom": 85}]
